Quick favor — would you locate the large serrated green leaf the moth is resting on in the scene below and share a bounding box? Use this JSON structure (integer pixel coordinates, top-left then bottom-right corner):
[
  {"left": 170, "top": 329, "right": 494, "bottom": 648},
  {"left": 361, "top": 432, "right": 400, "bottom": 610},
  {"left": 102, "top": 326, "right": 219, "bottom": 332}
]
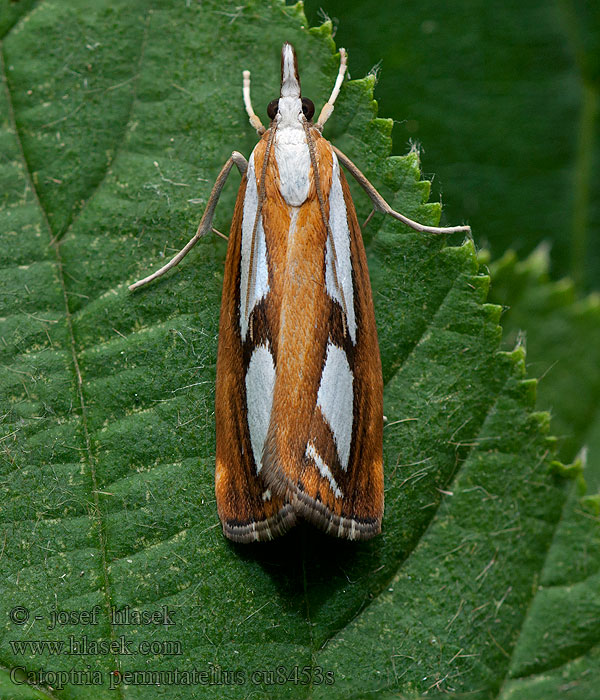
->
[{"left": 0, "top": 0, "right": 588, "bottom": 699}]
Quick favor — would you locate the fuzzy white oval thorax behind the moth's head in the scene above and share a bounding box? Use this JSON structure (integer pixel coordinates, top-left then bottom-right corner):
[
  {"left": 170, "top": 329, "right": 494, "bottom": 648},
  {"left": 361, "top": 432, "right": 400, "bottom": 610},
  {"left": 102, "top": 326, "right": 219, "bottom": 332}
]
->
[{"left": 275, "top": 114, "right": 311, "bottom": 207}]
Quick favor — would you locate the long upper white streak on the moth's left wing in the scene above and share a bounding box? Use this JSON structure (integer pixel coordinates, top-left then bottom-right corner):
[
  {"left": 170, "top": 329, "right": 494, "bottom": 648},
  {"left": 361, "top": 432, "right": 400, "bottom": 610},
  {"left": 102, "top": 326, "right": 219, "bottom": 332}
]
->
[{"left": 240, "top": 151, "right": 269, "bottom": 340}]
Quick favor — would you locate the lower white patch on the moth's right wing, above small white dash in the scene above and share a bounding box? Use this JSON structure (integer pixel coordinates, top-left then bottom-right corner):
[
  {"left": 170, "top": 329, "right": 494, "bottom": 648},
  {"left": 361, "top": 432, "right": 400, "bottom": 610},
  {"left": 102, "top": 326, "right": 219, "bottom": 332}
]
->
[{"left": 317, "top": 342, "right": 354, "bottom": 470}]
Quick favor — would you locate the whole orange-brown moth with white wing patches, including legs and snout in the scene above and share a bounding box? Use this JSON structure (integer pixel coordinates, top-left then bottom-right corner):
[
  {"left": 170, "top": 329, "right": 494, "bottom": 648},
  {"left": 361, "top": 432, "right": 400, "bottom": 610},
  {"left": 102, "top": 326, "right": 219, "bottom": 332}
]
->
[{"left": 130, "top": 43, "right": 469, "bottom": 542}]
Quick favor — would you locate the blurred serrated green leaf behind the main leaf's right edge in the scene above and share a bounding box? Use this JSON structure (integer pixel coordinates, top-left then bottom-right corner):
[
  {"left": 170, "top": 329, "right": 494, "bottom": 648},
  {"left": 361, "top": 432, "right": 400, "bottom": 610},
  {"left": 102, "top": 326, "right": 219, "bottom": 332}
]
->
[{"left": 491, "top": 246, "right": 600, "bottom": 470}]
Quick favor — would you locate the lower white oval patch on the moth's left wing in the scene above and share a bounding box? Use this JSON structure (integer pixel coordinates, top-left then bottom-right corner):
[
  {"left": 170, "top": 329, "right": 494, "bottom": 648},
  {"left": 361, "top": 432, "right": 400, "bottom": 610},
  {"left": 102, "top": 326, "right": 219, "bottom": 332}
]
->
[{"left": 246, "top": 344, "right": 275, "bottom": 474}]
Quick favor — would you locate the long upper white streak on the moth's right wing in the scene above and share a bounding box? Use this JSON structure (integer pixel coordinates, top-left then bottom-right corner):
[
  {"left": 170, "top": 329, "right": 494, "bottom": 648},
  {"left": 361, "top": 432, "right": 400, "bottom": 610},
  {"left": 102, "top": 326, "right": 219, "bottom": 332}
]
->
[{"left": 325, "top": 153, "right": 356, "bottom": 344}]
